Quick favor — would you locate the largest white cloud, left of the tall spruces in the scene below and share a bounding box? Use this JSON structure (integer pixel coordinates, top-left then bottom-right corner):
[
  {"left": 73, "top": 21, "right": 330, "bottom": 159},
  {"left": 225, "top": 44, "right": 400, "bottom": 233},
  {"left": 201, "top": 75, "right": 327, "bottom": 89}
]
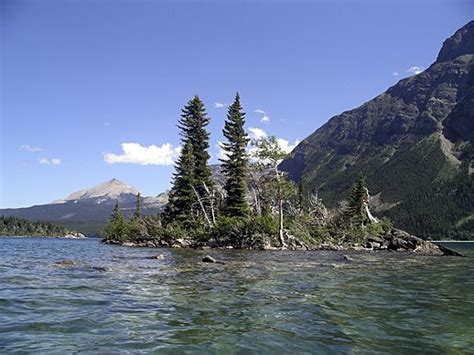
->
[{"left": 104, "top": 143, "right": 181, "bottom": 165}]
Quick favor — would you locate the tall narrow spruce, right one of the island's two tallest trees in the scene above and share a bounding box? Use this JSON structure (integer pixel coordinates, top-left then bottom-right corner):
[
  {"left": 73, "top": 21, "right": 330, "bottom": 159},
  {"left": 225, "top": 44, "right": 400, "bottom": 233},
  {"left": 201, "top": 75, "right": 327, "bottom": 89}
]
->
[{"left": 221, "top": 93, "right": 250, "bottom": 217}]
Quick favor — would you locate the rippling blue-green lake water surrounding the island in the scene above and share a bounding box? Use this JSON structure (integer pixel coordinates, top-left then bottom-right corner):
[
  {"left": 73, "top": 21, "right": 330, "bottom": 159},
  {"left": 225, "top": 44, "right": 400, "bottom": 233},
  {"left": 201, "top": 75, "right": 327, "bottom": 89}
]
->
[{"left": 0, "top": 238, "right": 474, "bottom": 354}]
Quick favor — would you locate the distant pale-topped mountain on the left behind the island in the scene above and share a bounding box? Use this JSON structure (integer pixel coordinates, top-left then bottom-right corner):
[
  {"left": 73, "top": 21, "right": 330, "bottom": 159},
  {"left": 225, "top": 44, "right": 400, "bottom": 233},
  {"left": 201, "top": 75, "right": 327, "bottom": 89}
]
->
[{"left": 0, "top": 179, "right": 168, "bottom": 235}]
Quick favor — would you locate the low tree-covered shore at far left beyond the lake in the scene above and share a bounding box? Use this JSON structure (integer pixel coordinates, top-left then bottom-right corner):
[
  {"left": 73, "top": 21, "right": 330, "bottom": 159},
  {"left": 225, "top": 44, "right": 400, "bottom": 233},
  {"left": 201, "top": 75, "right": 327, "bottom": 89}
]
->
[{"left": 0, "top": 216, "right": 70, "bottom": 237}]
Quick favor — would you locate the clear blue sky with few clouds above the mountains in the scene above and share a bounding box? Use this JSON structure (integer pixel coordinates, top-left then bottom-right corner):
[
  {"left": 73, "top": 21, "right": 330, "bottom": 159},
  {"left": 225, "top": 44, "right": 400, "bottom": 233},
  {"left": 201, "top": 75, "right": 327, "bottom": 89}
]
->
[{"left": 0, "top": 0, "right": 474, "bottom": 208}]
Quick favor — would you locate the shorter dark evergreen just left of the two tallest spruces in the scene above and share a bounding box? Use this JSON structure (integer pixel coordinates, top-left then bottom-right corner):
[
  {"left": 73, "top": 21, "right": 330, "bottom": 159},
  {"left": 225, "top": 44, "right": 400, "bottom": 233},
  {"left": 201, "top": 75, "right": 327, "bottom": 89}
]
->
[{"left": 163, "top": 140, "right": 196, "bottom": 223}]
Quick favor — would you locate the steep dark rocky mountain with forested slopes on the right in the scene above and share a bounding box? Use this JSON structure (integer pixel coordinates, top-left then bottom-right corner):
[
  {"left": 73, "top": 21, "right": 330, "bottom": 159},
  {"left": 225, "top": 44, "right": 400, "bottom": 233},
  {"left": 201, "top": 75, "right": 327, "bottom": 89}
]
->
[{"left": 281, "top": 21, "right": 474, "bottom": 239}]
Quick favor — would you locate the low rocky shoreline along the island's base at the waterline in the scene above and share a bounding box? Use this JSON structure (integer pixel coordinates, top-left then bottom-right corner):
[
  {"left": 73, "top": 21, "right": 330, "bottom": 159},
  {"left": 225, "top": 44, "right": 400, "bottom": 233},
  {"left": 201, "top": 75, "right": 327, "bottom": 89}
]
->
[{"left": 102, "top": 228, "right": 463, "bottom": 256}]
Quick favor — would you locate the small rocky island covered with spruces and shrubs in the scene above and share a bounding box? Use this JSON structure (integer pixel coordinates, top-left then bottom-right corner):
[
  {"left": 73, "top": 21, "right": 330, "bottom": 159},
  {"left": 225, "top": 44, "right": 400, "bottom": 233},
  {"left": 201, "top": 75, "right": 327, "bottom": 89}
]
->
[{"left": 103, "top": 93, "right": 458, "bottom": 255}]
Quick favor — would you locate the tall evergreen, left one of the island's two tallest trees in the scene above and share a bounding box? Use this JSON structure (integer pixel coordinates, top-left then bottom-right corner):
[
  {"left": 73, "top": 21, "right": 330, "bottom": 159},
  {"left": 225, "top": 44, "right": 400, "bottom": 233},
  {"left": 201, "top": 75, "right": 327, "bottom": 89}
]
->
[{"left": 178, "top": 95, "right": 213, "bottom": 197}]
